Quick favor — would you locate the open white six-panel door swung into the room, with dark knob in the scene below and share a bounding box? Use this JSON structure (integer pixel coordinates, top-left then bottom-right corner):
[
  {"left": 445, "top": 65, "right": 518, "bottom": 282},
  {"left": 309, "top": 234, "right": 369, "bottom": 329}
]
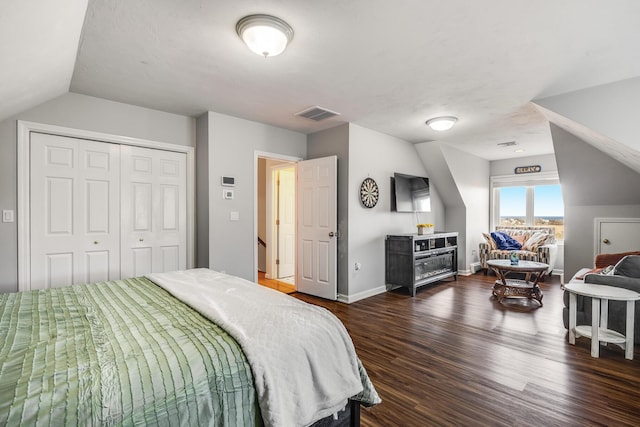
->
[{"left": 296, "top": 156, "right": 338, "bottom": 300}]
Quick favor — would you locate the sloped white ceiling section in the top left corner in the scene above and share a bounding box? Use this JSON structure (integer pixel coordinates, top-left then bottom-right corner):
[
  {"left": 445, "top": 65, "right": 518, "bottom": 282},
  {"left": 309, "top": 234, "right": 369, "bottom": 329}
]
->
[{"left": 0, "top": 0, "right": 88, "bottom": 121}]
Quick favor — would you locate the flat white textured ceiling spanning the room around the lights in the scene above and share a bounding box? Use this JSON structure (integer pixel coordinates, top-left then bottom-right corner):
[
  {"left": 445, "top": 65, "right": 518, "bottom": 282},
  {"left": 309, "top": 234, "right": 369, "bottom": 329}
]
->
[{"left": 0, "top": 0, "right": 640, "bottom": 160}]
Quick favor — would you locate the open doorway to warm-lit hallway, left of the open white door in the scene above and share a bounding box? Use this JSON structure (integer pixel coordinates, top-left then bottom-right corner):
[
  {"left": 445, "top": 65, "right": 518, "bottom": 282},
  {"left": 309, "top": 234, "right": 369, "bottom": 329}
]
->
[{"left": 256, "top": 156, "right": 296, "bottom": 293}]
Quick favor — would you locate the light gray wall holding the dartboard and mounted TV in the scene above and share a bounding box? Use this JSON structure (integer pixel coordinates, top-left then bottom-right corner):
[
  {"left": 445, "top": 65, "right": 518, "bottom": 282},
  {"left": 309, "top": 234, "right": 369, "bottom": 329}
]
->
[{"left": 307, "top": 124, "right": 446, "bottom": 302}]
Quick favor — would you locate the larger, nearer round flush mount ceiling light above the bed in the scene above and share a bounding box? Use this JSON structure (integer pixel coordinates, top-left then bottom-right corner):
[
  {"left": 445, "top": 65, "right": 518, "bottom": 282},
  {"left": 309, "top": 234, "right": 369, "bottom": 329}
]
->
[{"left": 236, "top": 15, "right": 293, "bottom": 58}]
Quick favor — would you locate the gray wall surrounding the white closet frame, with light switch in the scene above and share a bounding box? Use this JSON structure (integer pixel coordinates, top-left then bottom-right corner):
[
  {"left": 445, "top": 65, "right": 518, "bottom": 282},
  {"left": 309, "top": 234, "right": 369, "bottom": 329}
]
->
[{"left": 0, "top": 93, "right": 196, "bottom": 292}]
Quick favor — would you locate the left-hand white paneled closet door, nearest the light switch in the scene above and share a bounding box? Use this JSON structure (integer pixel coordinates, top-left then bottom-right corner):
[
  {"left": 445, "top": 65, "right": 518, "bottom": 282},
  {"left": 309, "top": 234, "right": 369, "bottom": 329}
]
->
[{"left": 30, "top": 133, "right": 120, "bottom": 289}]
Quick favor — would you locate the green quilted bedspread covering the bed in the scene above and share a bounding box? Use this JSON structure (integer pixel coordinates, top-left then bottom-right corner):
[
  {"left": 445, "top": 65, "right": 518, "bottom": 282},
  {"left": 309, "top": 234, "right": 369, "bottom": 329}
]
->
[{"left": 0, "top": 278, "right": 261, "bottom": 426}]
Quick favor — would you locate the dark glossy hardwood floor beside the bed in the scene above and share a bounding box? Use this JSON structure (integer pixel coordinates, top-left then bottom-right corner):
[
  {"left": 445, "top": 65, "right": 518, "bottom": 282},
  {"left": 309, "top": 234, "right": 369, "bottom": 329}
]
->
[{"left": 293, "top": 273, "right": 640, "bottom": 426}]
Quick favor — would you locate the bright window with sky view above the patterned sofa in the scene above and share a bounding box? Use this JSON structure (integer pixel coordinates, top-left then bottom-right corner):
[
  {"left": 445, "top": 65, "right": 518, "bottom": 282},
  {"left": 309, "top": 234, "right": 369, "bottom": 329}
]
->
[{"left": 491, "top": 174, "right": 564, "bottom": 240}]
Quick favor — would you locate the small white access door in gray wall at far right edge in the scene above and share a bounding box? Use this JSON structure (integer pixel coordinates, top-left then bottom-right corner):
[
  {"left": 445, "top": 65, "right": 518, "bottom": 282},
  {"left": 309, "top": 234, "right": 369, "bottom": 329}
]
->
[{"left": 595, "top": 218, "right": 640, "bottom": 255}]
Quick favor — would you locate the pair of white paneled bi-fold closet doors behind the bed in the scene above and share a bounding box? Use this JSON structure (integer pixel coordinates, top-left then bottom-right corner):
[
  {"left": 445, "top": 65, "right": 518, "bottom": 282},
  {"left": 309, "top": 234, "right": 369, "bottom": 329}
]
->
[{"left": 29, "top": 132, "right": 187, "bottom": 289}]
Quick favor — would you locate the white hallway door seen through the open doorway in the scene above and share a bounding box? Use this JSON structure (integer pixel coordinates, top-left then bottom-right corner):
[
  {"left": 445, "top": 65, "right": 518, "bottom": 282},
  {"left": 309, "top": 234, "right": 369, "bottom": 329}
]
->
[{"left": 277, "top": 166, "right": 296, "bottom": 279}]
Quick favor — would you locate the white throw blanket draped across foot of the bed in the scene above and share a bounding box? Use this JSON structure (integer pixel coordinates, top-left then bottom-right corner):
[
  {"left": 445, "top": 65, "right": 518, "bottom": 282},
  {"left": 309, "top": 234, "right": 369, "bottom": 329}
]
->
[{"left": 147, "top": 269, "right": 363, "bottom": 427}]
